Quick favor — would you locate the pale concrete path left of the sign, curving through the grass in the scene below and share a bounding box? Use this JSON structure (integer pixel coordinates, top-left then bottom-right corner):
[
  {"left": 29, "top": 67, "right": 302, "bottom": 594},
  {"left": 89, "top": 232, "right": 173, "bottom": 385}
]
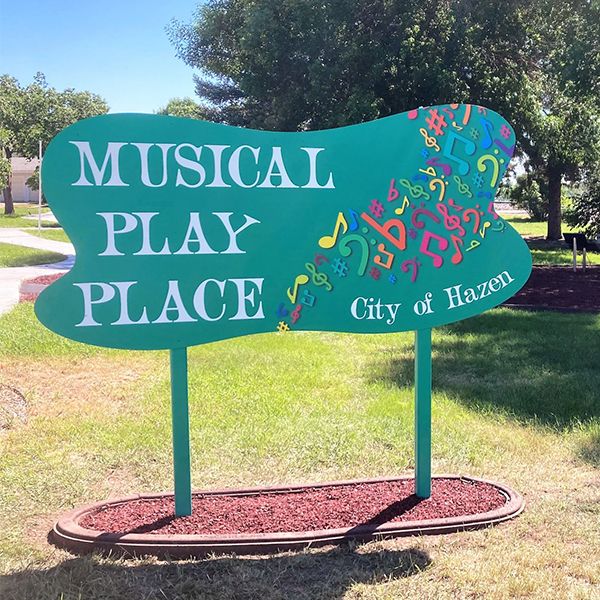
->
[{"left": 0, "top": 228, "right": 75, "bottom": 315}]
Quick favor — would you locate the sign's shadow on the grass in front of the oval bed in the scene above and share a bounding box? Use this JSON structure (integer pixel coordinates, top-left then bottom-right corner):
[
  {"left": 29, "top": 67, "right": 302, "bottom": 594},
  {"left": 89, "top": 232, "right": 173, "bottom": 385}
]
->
[{"left": 0, "top": 546, "right": 431, "bottom": 600}]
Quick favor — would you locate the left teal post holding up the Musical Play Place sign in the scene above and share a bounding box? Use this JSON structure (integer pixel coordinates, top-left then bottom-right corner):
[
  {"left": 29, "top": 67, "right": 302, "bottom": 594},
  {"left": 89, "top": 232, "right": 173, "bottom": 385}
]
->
[{"left": 170, "top": 348, "right": 192, "bottom": 517}]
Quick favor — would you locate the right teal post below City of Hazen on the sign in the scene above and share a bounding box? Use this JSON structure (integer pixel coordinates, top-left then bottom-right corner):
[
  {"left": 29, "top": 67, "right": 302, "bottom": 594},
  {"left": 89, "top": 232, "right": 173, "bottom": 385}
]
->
[{"left": 415, "top": 329, "right": 431, "bottom": 498}]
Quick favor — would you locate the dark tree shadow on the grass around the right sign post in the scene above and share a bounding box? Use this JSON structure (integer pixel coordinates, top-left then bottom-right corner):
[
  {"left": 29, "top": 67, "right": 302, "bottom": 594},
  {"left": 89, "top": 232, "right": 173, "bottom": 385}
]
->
[{"left": 370, "top": 309, "right": 600, "bottom": 429}]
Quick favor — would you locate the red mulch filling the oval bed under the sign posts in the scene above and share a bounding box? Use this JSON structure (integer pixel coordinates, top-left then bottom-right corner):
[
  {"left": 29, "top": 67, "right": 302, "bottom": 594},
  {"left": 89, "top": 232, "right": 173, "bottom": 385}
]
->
[{"left": 79, "top": 478, "right": 507, "bottom": 535}]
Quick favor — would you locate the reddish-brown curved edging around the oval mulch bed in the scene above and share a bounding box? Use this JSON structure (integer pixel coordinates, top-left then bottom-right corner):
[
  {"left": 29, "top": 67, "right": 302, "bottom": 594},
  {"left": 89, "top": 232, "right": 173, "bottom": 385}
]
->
[{"left": 48, "top": 475, "right": 525, "bottom": 558}]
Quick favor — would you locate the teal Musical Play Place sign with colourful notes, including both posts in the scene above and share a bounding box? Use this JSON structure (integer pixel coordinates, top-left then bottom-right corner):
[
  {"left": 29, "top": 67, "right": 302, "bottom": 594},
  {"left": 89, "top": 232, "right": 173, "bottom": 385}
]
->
[{"left": 35, "top": 104, "right": 531, "bottom": 516}]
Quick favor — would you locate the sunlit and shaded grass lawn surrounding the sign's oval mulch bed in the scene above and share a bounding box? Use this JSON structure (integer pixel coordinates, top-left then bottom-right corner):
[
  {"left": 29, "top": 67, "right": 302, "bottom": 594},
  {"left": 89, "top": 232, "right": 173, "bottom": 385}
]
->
[{"left": 0, "top": 304, "right": 600, "bottom": 600}]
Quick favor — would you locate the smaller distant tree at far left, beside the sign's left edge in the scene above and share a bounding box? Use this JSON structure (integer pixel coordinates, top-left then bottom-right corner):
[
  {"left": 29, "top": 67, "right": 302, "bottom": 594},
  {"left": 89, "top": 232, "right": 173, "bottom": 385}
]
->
[{"left": 0, "top": 73, "right": 108, "bottom": 214}]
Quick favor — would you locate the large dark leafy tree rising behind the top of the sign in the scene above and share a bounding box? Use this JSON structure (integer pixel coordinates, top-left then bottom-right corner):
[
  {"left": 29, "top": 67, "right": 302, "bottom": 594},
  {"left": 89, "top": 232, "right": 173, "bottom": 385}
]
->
[{"left": 169, "top": 0, "right": 600, "bottom": 238}]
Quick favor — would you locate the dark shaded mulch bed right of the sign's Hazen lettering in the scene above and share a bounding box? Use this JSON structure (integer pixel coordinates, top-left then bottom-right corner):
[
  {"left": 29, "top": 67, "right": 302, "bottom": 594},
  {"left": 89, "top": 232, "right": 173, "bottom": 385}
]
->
[{"left": 506, "top": 266, "right": 600, "bottom": 312}]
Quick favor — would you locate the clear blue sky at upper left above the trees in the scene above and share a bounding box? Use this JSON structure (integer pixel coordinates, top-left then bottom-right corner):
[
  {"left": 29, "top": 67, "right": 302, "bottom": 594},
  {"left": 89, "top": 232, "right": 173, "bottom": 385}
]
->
[{"left": 0, "top": 0, "right": 199, "bottom": 112}]
